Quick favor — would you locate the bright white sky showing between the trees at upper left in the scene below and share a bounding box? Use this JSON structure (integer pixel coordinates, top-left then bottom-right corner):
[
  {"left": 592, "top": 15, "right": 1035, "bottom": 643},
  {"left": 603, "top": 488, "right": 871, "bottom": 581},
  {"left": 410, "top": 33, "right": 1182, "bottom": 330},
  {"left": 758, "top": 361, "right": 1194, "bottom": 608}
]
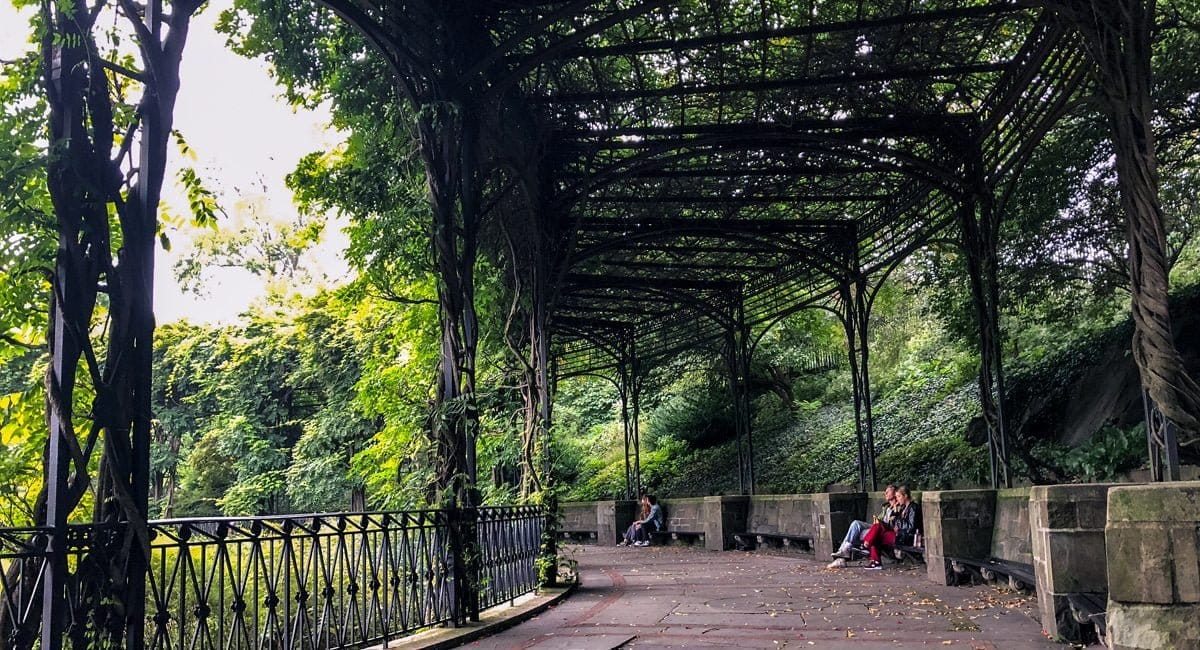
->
[{"left": 0, "top": 0, "right": 349, "bottom": 324}]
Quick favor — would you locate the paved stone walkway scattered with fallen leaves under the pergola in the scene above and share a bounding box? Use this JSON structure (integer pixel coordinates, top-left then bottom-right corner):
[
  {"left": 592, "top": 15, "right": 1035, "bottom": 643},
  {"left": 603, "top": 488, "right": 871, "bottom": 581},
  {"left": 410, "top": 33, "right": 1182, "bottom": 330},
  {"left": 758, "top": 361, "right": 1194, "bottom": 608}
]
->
[{"left": 467, "top": 546, "right": 1068, "bottom": 650}]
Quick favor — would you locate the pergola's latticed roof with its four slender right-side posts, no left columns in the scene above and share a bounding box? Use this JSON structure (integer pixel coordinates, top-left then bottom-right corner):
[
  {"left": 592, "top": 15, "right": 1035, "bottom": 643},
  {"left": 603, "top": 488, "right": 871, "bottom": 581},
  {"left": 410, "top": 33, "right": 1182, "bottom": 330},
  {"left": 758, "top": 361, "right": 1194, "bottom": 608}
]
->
[{"left": 369, "top": 1, "right": 1088, "bottom": 495}]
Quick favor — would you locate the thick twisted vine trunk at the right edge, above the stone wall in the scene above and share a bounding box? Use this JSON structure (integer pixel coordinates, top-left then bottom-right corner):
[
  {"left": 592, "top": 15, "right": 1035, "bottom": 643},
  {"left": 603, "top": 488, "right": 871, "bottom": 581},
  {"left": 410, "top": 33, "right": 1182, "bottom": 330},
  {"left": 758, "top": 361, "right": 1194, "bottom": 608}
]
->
[{"left": 1050, "top": 0, "right": 1200, "bottom": 453}]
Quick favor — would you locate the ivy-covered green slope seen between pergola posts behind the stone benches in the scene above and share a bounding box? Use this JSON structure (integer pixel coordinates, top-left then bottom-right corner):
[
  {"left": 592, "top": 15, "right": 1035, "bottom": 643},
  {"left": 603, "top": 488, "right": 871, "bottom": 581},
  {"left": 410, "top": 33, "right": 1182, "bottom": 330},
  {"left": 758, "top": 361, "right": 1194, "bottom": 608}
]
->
[{"left": 565, "top": 288, "right": 1200, "bottom": 499}]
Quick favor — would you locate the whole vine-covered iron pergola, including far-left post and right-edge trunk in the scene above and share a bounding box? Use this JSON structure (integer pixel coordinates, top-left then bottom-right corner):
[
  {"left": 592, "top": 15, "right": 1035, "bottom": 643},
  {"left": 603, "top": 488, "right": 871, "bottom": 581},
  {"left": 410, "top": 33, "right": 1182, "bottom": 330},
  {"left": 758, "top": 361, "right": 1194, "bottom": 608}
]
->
[{"left": 21, "top": 0, "right": 1200, "bottom": 650}]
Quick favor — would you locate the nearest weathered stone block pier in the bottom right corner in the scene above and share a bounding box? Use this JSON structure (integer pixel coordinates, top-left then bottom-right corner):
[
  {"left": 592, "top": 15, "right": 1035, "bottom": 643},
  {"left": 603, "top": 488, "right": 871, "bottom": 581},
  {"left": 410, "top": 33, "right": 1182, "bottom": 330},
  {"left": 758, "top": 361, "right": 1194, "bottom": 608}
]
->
[{"left": 1104, "top": 481, "right": 1200, "bottom": 650}]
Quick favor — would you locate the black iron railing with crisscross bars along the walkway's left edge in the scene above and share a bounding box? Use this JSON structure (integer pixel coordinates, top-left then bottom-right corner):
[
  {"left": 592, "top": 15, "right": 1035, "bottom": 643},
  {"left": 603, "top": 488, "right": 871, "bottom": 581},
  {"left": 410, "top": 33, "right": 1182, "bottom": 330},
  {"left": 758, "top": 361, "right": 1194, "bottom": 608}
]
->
[{"left": 0, "top": 506, "right": 546, "bottom": 650}]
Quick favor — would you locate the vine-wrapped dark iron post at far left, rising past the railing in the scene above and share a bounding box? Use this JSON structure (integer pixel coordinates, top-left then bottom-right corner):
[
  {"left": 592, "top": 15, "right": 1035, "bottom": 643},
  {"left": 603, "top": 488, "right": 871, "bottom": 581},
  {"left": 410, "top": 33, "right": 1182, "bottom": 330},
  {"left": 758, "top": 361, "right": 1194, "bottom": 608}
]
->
[{"left": 14, "top": 0, "right": 199, "bottom": 650}]
